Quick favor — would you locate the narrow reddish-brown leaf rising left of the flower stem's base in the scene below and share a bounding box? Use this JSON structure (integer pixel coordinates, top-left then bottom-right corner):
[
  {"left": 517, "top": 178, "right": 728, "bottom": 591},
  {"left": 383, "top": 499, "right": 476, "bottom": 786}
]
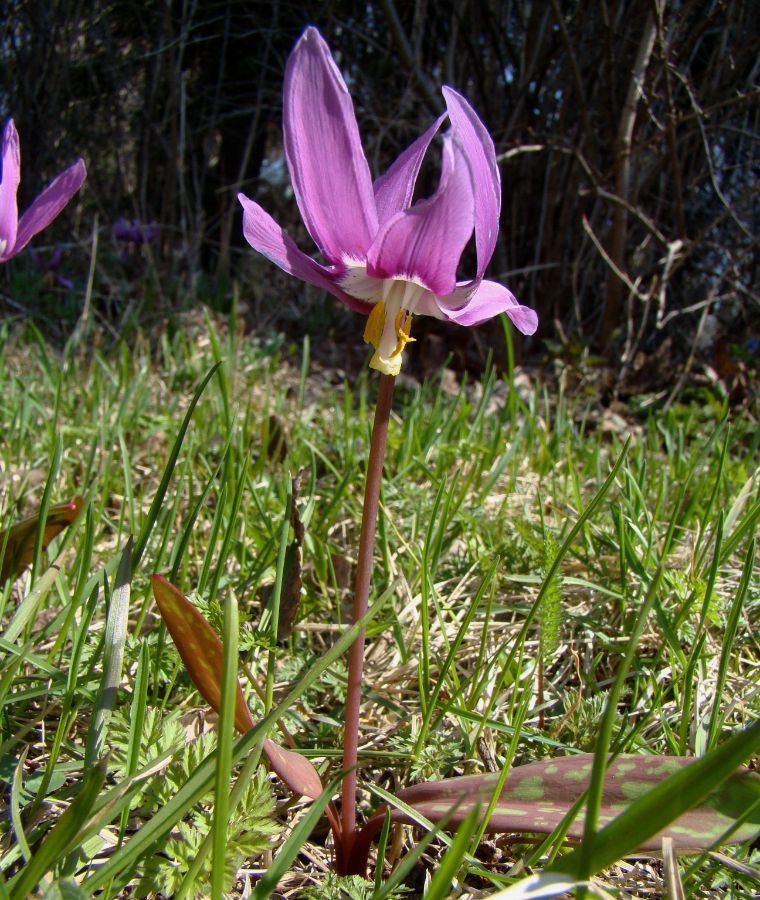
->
[{"left": 152, "top": 575, "right": 322, "bottom": 799}]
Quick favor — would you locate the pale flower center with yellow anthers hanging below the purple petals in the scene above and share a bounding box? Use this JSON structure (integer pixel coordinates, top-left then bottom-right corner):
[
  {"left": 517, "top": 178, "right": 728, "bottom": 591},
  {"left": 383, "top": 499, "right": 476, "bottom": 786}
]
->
[{"left": 364, "top": 278, "right": 425, "bottom": 375}]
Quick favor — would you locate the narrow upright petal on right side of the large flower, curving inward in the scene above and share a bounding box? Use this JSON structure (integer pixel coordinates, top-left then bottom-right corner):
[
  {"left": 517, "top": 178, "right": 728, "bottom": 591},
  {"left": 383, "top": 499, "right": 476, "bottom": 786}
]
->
[{"left": 443, "top": 87, "right": 501, "bottom": 281}]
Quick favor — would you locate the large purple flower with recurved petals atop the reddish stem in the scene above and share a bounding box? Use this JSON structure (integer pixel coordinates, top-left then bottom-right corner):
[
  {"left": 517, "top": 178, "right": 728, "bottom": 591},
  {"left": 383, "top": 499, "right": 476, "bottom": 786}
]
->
[{"left": 238, "top": 28, "right": 538, "bottom": 375}]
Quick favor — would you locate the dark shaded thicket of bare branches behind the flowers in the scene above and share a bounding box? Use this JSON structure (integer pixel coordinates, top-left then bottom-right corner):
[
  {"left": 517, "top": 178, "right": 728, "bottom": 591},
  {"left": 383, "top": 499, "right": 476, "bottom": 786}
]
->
[{"left": 0, "top": 0, "right": 760, "bottom": 378}]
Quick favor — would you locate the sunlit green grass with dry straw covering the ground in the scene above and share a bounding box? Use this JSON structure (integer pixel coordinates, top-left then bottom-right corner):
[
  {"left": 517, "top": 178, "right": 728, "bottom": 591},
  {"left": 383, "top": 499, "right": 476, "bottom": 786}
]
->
[{"left": 0, "top": 317, "right": 760, "bottom": 896}]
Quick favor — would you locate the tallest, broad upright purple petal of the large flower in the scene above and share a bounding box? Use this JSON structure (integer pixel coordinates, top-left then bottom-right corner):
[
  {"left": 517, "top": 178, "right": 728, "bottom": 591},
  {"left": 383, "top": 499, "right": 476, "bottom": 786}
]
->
[{"left": 283, "top": 27, "right": 377, "bottom": 264}]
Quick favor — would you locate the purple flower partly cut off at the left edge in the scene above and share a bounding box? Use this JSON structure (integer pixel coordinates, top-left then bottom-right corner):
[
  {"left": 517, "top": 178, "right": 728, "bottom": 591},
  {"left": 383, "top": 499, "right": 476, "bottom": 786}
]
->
[{"left": 0, "top": 119, "right": 87, "bottom": 262}]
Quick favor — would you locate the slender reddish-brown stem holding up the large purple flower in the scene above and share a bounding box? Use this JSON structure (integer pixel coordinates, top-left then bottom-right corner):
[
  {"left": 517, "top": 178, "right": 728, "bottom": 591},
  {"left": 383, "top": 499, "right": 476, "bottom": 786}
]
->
[{"left": 341, "top": 375, "right": 396, "bottom": 853}]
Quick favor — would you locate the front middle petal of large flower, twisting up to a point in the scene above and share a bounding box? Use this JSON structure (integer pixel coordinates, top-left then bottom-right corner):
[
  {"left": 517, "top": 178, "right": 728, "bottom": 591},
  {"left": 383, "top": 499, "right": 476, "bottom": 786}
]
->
[{"left": 367, "top": 136, "right": 475, "bottom": 295}]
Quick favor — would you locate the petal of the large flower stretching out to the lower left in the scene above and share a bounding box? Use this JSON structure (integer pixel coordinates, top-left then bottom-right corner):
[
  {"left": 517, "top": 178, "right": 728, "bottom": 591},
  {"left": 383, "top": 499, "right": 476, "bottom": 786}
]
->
[{"left": 238, "top": 194, "right": 370, "bottom": 313}]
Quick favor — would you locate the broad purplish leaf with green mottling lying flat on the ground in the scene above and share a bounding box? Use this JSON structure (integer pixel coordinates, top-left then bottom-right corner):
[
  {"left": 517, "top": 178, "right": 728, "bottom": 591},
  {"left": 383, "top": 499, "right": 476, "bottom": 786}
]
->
[{"left": 368, "top": 753, "right": 760, "bottom": 852}]
